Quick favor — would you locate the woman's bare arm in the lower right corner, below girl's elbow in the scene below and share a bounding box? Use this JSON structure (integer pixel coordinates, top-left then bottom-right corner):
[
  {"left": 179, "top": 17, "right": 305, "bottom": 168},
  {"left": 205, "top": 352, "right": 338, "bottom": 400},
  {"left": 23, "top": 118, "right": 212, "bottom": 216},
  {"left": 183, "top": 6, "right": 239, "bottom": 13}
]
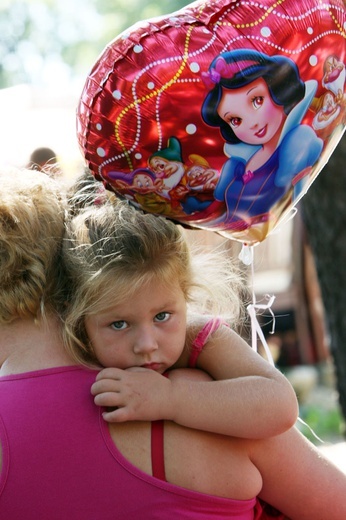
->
[{"left": 251, "top": 428, "right": 346, "bottom": 520}]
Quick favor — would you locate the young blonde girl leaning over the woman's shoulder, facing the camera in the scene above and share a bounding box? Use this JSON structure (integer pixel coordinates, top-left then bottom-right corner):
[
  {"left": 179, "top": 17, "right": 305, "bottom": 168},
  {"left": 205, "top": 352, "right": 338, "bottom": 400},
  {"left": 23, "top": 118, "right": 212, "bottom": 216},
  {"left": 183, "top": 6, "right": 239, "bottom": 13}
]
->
[{"left": 64, "top": 195, "right": 297, "bottom": 438}]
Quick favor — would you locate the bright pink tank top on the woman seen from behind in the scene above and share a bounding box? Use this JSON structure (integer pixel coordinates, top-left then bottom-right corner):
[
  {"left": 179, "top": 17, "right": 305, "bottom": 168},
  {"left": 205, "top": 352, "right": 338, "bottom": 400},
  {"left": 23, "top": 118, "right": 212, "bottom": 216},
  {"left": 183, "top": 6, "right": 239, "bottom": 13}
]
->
[{"left": 0, "top": 367, "right": 256, "bottom": 520}]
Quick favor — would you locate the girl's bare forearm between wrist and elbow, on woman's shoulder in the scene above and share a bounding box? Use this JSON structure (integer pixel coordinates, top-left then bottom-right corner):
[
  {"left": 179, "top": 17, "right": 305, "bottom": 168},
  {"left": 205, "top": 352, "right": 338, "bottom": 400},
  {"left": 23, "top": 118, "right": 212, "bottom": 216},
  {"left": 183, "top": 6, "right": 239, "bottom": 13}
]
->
[{"left": 167, "top": 376, "right": 298, "bottom": 439}]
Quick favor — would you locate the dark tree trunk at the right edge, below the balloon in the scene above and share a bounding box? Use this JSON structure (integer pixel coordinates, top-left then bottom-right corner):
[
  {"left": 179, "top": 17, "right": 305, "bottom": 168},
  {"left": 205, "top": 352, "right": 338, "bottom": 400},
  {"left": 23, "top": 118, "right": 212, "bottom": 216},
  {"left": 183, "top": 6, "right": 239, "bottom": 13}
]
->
[{"left": 300, "top": 137, "right": 346, "bottom": 428}]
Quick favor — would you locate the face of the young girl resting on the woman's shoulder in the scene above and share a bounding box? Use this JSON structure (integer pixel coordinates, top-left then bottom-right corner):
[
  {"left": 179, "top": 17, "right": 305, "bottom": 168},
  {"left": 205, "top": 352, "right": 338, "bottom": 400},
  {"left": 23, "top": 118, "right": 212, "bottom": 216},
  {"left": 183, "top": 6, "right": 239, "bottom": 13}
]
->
[{"left": 85, "top": 281, "right": 186, "bottom": 374}]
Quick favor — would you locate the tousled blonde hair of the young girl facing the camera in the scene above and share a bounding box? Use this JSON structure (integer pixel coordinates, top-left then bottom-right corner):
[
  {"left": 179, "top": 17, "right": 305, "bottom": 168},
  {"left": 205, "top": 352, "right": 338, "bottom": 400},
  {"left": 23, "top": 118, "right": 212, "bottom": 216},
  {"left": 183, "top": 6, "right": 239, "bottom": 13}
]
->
[{"left": 63, "top": 201, "right": 241, "bottom": 365}]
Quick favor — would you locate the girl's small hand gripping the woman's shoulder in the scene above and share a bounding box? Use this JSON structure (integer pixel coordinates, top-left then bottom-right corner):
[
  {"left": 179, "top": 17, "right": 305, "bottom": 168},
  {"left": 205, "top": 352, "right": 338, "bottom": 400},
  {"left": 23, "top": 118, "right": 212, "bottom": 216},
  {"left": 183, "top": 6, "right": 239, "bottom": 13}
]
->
[{"left": 91, "top": 367, "right": 172, "bottom": 422}]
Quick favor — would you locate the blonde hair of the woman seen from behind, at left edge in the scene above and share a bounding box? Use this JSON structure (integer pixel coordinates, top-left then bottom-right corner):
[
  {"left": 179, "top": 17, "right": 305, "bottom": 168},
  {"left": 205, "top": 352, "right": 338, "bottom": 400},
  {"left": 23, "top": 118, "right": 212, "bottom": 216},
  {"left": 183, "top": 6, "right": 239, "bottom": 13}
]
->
[{"left": 0, "top": 168, "right": 66, "bottom": 324}]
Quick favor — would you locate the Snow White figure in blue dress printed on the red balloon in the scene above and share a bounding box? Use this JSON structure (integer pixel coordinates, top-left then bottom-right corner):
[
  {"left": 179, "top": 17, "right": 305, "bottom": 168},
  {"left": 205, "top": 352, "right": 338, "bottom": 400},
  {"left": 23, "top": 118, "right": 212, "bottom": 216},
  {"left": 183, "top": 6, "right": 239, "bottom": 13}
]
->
[{"left": 202, "top": 49, "right": 323, "bottom": 227}]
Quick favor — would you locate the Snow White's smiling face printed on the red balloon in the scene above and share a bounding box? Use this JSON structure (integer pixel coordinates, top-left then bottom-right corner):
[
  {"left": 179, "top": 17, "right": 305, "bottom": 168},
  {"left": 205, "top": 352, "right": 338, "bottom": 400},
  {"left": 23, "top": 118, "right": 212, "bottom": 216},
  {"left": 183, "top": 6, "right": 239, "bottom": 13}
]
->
[{"left": 217, "top": 78, "right": 286, "bottom": 145}]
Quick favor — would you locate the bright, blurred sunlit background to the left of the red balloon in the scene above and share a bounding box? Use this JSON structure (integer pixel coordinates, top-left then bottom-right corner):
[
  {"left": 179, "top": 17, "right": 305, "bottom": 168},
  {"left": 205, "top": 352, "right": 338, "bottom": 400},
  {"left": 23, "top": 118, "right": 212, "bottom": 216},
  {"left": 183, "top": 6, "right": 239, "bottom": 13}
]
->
[{"left": 0, "top": 0, "right": 189, "bottom": 178}]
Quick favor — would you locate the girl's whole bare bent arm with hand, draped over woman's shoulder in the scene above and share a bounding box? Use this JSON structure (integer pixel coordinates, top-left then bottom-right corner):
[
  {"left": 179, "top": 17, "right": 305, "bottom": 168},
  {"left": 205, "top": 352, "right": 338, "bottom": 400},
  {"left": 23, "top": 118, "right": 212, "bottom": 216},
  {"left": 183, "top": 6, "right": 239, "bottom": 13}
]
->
[{"left": 92, "top": 318, "right": 298, "bottom": 439}]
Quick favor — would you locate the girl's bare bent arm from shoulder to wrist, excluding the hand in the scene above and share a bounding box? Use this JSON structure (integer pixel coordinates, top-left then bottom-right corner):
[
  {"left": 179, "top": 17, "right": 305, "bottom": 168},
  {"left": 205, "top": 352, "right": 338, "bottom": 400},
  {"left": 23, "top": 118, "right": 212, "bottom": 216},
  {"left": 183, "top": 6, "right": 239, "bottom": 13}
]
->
[{"left": 169, "top": 318, "right": 298, "bottom": 439}]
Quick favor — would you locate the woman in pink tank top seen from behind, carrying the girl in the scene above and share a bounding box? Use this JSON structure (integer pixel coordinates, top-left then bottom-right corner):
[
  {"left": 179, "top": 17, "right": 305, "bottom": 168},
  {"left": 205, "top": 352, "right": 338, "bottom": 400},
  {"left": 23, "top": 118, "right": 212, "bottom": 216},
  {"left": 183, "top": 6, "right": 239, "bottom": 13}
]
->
[{"left": 0, "top": 172, "right": 346, "bottom": 520}]
